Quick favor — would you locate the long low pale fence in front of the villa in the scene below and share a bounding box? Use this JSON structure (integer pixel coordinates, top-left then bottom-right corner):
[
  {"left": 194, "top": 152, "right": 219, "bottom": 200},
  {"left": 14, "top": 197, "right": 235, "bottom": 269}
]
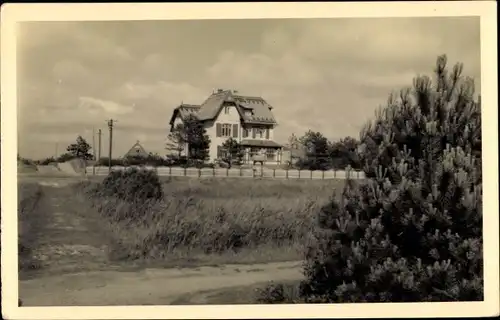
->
[{"left": 86, "top": 166, "right": 365, "bottom": 180}]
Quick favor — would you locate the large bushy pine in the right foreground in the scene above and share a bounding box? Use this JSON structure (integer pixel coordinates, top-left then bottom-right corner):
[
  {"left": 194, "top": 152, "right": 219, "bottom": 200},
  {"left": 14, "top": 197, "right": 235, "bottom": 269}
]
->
[{"left": 302, "top": 56, "right": 483, "bottom": 302}]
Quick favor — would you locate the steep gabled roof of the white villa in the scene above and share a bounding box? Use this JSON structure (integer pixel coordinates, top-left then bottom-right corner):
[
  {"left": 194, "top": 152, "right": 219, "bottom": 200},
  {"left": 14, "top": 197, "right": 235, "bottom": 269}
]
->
[{"left": 170, "top": 90, "right": 276, "bottom": 125}]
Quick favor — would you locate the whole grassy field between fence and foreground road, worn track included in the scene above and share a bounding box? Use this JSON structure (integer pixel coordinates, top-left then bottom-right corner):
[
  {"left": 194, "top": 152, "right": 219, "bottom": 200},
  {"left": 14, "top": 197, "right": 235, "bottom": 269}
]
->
[{"left": 18, "top": 177, "right": 343, "bottom": 277}]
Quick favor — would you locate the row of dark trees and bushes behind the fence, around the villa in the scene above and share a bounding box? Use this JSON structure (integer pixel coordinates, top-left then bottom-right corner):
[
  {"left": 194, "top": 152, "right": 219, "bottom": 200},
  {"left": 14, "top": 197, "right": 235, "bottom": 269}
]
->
[{"left": 18, "top": 115, "right": 361, "bottom": 170}]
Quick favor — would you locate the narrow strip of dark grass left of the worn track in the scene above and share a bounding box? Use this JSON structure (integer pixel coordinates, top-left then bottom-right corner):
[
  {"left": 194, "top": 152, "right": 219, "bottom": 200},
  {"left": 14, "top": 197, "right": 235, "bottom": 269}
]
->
[{"left": 17, "top": 183, "right": 42, "bottom": 270}]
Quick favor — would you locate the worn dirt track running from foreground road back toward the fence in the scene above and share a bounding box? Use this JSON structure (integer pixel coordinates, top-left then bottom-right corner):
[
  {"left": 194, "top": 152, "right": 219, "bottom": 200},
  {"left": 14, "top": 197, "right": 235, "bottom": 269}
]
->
[{"left": 21, "top": 179, "right": 109, "bottom": 273}]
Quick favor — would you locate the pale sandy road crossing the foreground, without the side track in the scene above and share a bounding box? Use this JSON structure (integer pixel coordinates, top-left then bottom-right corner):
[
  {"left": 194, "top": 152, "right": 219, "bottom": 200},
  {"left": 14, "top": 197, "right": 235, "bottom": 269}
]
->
[{"left": 19, "top": 262, "right": 302, "bottom": 306}]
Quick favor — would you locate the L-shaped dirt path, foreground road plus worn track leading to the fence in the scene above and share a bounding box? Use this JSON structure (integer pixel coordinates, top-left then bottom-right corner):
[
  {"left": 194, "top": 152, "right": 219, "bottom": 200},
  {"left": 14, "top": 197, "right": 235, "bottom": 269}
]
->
[{"left": 19, "top": 179, "right": 302, "bottom": 306}]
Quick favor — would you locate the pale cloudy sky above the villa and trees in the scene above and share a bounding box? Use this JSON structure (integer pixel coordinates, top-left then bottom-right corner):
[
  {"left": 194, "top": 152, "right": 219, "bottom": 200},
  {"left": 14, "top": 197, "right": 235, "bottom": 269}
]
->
[{"left": 17, "top": 17, "right": 481, "bottom": 159}]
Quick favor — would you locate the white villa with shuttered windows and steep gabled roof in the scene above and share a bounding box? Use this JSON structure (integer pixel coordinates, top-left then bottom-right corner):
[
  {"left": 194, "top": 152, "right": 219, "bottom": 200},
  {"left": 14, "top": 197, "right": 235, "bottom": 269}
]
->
[{"left": 170, "top": 89, "right": 282, "bottom": 164}]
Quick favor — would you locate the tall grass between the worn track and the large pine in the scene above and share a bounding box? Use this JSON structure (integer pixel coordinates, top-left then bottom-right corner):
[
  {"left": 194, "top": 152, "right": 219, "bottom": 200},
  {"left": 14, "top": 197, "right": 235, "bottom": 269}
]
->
[{"left": 80, "top": 178, "right": 342, "bottom": 259}]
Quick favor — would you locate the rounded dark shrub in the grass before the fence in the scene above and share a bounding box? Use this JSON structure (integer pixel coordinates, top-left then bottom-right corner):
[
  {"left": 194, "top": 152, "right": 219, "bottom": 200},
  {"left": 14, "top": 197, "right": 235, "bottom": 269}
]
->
[{"left": 100, "top": 168, "right": 163, "bottom": 202}]
